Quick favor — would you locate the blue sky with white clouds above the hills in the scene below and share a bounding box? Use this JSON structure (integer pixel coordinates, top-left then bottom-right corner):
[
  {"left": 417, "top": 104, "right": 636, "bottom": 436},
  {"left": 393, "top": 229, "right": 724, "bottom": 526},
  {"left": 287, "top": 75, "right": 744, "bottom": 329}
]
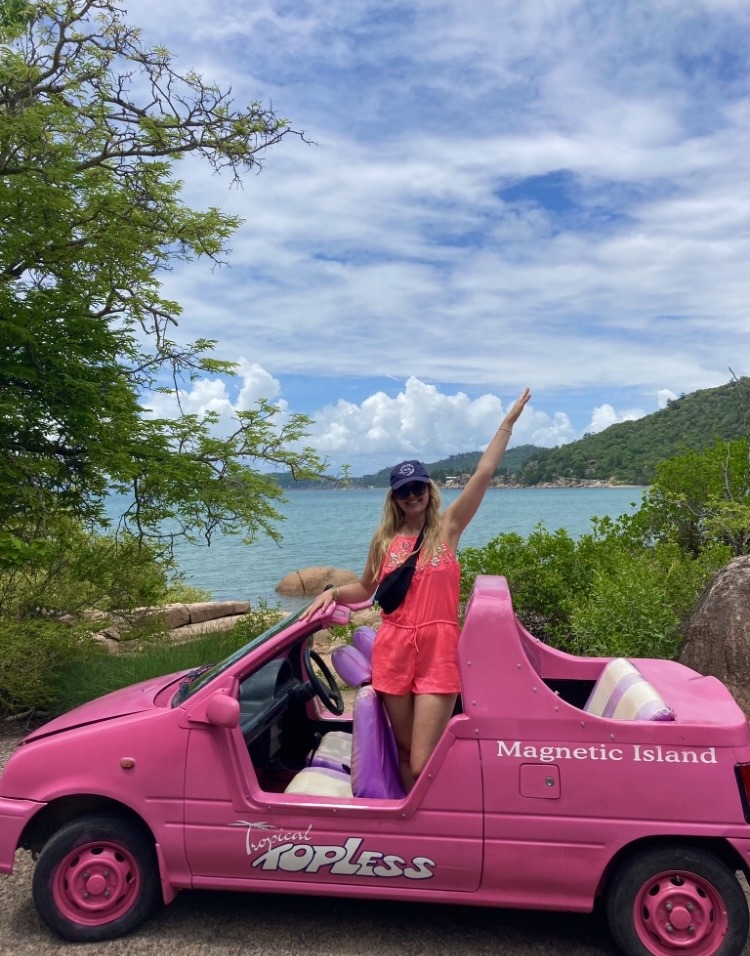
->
[{"left": 126, "top": 0, "right": 750, "bottom": 475}]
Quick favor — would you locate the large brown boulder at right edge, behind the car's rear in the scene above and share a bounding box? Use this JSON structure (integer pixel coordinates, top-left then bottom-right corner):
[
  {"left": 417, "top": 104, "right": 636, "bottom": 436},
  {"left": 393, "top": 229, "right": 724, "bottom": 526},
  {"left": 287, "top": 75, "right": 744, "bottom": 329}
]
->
[{"left": 680, "top": 555, "right": 750, "bottom": 713}]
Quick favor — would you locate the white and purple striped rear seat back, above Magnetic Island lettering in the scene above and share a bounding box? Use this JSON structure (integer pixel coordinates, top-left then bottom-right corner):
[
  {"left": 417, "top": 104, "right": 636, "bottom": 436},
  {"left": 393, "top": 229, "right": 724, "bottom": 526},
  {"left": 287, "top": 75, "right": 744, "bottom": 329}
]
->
[{"left": 584, "top": 657, "right": 675, "bottom": 720}]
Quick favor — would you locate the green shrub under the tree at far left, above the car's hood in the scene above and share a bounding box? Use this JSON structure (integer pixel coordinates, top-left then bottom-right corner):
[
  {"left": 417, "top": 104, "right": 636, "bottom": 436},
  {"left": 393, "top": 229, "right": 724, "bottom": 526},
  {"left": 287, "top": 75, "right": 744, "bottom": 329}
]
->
[{"left": 0, "top": 515, "right": 212, "bottom": 714}]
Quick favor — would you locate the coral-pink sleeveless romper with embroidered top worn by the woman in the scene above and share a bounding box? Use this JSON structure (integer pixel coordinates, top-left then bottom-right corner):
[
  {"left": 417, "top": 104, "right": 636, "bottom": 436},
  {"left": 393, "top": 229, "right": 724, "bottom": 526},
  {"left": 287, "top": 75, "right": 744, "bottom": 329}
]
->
[{"left": 372, "top": 535, "right": 461, "bottom": 695}]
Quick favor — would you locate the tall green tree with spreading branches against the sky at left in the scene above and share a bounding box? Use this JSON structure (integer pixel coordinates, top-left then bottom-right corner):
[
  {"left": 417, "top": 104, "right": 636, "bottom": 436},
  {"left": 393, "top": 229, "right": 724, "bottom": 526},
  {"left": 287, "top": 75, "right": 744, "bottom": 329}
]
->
[{"left": 0, "top": 0, "right": 320, "bottom": 565}]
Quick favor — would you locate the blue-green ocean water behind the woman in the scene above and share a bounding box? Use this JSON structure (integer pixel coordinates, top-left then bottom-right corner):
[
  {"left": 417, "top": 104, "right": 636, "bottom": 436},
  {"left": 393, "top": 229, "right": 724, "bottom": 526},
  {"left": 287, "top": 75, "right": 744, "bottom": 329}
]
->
[{"left": 170, "top": 488, "right": 644, "bottom": 611}]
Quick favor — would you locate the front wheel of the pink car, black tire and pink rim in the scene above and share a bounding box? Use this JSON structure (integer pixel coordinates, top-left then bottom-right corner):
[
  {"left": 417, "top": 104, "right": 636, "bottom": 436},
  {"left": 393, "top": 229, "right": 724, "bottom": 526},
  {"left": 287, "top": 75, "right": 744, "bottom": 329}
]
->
[{"left": 32, "top": 814, "right": 160, "bottom": 943}]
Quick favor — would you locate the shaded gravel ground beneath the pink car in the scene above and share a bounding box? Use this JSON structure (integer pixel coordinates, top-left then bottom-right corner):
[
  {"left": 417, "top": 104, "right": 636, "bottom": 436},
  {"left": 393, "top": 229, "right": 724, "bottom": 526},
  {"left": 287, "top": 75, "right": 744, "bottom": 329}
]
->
[{"left": 0, "top": 724, "right": 750, "bottom": 956}]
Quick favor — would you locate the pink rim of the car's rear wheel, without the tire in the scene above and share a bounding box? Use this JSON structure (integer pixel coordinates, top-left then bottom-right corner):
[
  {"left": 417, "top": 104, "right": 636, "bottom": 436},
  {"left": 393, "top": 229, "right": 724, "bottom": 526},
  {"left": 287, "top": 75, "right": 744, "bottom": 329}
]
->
[{"left": 633, "top": 870, "right": 729, "bottom": 956}]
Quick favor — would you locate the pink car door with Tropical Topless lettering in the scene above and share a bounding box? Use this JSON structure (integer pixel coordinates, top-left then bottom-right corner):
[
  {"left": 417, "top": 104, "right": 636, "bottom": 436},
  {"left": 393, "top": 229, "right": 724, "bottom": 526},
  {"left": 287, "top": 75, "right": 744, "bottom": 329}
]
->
[{"left": 185, "top": 726, "right": 482, "bottom": 895}]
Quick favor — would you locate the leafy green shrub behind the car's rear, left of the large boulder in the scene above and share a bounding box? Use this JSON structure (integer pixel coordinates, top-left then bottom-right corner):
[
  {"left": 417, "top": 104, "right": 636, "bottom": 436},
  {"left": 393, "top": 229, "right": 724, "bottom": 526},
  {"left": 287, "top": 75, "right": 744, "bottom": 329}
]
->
[{"left": 460, "top": 519, "right": 731, "bottom": 657}]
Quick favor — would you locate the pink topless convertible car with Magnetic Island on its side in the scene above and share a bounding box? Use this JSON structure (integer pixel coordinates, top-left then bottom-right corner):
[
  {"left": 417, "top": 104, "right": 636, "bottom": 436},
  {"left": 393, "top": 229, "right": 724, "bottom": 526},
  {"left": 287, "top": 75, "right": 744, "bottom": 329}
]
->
[{"left": 0, "top": 576, "right": 750, "bottom": 956}]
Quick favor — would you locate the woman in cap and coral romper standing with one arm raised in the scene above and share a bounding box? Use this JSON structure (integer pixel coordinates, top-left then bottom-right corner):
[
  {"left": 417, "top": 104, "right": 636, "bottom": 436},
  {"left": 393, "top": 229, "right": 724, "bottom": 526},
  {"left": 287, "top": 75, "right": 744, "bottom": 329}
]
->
[{"left": 304, "top": 388, "right": 531, "bottom": 790}]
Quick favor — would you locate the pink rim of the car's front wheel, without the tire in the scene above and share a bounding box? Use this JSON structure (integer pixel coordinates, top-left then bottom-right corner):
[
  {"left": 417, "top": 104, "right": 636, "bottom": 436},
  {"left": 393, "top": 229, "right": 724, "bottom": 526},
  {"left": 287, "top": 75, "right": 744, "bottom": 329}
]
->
[{"left": 52, "top": 842, "right": 141, "bottom": 926}]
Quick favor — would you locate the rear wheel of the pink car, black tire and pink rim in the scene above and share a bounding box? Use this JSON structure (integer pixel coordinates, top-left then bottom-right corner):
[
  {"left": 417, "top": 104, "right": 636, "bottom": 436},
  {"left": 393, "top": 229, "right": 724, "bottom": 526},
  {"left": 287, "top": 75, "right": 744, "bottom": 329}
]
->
[{"left": 606, "top": 843, "right": 750, "bottom": 956}]
